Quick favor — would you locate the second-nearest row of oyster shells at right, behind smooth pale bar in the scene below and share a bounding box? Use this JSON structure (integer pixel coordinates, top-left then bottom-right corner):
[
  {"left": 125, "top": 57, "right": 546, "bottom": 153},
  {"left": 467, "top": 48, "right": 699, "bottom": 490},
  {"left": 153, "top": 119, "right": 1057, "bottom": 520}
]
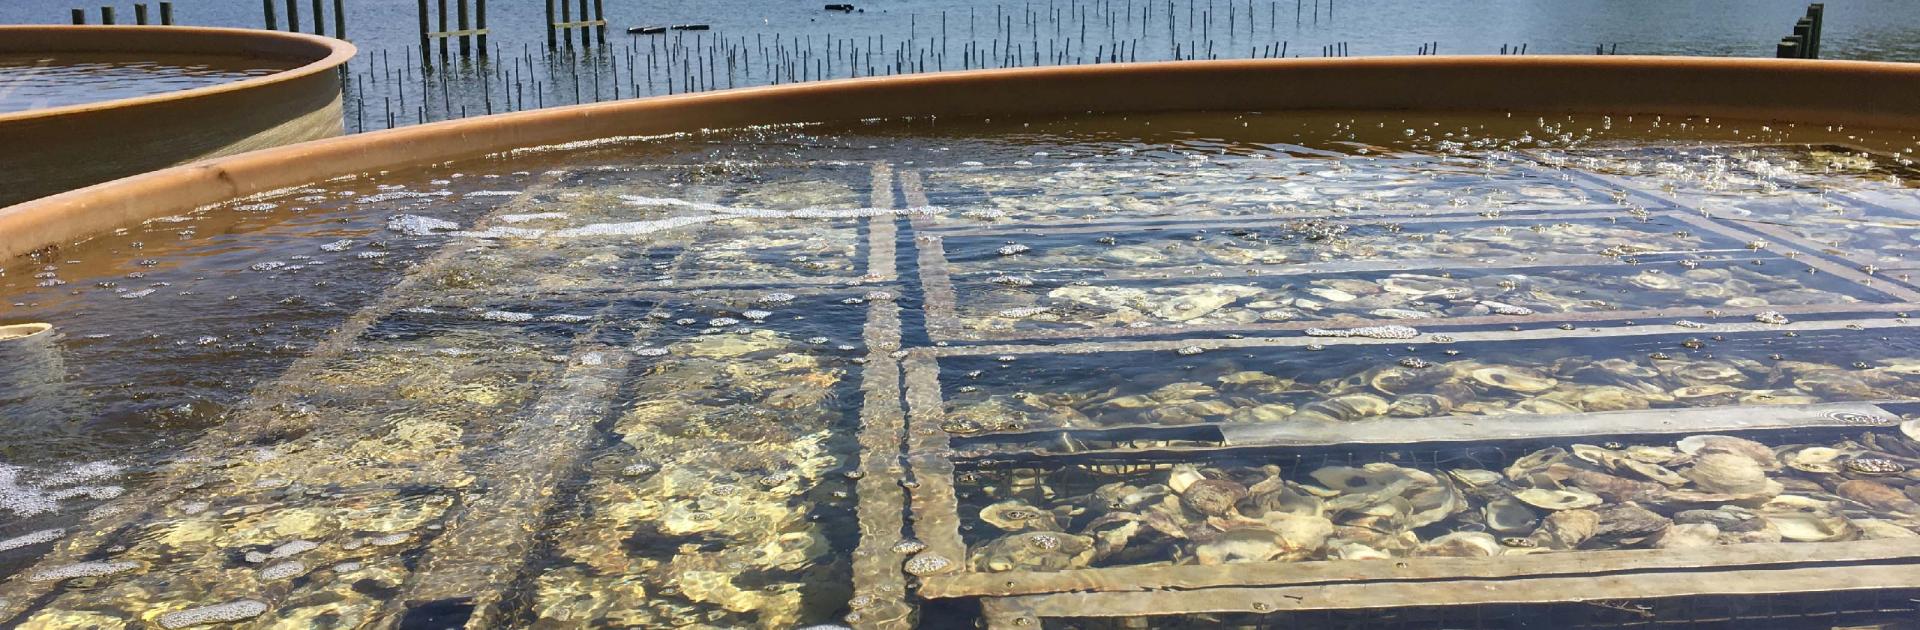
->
[{"left": 941, "top": 347, "right": 1920, "bottom": 434}]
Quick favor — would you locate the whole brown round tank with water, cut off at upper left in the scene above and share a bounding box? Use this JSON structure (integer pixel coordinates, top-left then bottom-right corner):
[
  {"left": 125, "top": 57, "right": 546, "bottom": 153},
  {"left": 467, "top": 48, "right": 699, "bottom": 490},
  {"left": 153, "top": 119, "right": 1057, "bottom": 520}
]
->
[{"left": 0, "top": 27, "right": 355, "bottom": 204}]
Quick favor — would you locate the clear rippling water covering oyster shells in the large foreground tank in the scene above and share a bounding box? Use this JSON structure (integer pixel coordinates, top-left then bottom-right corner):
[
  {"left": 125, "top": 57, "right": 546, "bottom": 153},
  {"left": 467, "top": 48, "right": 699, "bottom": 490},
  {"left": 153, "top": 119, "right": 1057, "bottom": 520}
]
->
[{"left": 0, "top": 113, "right": 1920, "bottom": 628}]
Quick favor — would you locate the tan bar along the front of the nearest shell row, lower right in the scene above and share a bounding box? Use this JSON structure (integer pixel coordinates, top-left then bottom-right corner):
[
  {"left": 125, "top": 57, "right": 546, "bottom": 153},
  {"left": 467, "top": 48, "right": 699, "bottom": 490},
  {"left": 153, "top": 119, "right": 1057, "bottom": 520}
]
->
[{"left": 920, "top": 538, "right": 1920, "bottom": 597}]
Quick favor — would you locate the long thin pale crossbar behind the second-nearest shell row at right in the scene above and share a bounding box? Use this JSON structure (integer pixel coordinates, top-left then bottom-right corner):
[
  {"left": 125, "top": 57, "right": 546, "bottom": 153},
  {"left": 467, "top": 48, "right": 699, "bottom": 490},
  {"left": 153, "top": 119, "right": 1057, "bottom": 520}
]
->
[{"left": 922, "top": 315, "right": 1914, "bottom": 357}]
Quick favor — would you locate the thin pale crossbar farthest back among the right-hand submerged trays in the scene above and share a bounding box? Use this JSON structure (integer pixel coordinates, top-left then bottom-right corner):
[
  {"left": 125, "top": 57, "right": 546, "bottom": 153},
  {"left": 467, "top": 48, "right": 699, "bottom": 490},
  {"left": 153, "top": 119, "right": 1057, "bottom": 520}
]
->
[{"left": 913, "top": 204, "right": 1626, "bottom": 238}]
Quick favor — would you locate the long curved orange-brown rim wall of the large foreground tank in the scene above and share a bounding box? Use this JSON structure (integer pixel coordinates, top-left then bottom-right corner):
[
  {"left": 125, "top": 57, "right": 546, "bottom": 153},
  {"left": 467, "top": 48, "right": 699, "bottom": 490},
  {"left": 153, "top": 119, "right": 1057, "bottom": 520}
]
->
[{"left": 0, "top": 56, "right": 1920, "bottom": 259}]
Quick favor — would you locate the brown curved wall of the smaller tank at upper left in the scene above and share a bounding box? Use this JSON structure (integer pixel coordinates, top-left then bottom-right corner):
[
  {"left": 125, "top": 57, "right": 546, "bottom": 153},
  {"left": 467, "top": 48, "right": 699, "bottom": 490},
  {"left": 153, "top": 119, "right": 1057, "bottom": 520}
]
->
[{"left": 0, "top": 27, "right": 353, "bottom": 204}]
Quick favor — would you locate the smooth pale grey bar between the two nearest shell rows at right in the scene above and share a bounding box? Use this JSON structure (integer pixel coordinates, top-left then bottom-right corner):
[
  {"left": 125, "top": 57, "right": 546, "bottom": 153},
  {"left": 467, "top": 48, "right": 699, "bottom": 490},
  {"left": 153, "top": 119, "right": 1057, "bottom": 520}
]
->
[{"left": 962, "top": 401, "right": 1899, "bottom": 465}]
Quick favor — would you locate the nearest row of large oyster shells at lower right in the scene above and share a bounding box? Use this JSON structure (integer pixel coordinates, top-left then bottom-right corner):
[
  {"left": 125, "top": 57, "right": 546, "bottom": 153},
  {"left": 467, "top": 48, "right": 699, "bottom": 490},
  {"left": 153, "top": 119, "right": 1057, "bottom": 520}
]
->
[{"left": 970, "top": 421, "right": 1920, "bottom": 572}]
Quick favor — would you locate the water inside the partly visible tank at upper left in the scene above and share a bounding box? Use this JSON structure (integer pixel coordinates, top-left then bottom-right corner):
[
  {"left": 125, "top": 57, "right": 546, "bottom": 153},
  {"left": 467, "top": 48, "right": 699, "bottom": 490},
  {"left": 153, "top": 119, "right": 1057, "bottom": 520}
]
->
[{"left": 0, "top": 54, "right": 294, "bottom": 111}]
